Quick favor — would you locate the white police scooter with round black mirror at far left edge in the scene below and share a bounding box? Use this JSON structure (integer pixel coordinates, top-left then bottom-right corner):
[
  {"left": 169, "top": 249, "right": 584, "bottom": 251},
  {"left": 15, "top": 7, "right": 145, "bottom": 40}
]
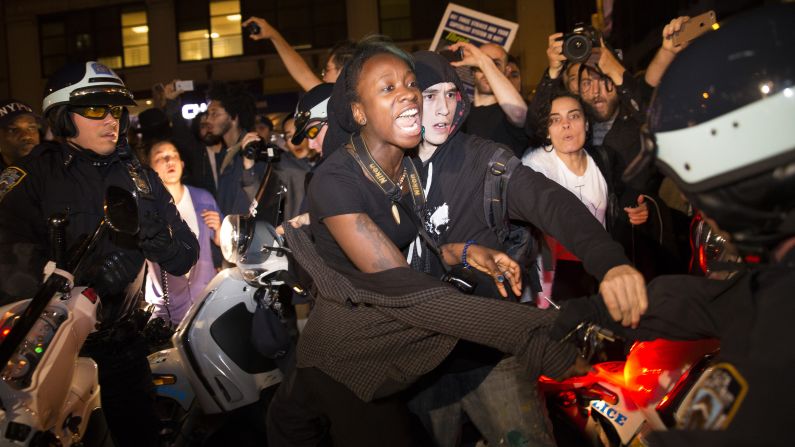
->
[{"left": 0, "top": 186, "right": 138, "bottom": 446}]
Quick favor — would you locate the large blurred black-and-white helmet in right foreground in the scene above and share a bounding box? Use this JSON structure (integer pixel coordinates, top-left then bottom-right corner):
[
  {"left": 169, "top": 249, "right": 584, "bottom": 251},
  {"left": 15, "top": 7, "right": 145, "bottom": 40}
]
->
[{"left": 625, "top": 4, "right": 795, "bottom": 254}]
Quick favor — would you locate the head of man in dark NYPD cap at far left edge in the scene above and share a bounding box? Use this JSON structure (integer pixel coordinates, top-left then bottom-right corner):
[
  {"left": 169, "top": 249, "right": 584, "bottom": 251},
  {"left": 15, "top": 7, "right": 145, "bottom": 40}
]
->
[{"left": 0, "top": 99, "right": 41, "bottom": 171}]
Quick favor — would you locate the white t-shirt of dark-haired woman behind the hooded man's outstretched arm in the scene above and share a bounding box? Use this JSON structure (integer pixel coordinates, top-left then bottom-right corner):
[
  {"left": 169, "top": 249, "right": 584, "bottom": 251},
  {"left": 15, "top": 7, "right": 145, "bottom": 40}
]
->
[{"left": 522, "top": 148, "right": 607, "bottom": 227}]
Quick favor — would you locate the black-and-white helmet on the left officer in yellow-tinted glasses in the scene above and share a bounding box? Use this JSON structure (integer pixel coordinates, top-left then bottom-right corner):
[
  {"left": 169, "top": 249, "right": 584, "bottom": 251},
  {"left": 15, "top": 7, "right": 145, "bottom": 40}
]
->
[{"left": 42, "top": 61, "right": 135, "bottom": 137}]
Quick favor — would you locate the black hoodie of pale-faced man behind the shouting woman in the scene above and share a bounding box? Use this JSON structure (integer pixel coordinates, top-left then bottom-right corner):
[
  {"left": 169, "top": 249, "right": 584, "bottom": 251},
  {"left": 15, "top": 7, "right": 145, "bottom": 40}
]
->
[{"left": 414, "top": 51, "right": 630, "bottom": 280}]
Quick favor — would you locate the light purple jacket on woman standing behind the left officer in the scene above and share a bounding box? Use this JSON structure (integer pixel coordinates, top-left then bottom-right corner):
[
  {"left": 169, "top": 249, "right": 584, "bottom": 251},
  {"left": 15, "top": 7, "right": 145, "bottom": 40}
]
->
[{"left": 146, "top": 185, "right": 224, "bottom": 325}]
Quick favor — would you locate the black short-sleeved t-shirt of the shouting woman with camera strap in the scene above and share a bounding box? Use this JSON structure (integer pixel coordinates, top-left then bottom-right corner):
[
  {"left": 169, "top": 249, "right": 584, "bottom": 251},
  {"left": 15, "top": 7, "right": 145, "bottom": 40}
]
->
[{"left": 307, "top": 148, "right": 417, "bottom": 273}]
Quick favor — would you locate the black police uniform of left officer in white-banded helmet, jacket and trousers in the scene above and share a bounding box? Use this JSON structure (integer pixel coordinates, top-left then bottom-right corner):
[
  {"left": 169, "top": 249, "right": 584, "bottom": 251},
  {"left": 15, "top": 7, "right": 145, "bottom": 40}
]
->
[{"left": 0, "top": 142, "right": 199, "bottom": 446}]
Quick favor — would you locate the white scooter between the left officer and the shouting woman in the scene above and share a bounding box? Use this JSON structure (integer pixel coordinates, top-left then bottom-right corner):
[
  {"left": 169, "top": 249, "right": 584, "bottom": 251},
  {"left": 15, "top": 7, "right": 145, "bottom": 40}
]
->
[{"left": 149, "top": 143, "right": 293, "bottom": 445}]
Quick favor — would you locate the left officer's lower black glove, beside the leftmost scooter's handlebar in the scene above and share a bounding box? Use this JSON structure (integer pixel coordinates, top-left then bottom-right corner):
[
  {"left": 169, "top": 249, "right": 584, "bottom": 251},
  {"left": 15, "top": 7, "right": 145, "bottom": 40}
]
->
[{"left": 78, "top": 251, "right": 143, "bottom": 298}]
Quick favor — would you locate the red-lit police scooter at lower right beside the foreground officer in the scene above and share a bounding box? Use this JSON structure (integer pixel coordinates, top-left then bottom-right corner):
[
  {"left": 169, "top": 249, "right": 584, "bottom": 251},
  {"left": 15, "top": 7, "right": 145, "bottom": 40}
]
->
[{"left": 539, "top": 226, "right": 743, "bottom": 446}]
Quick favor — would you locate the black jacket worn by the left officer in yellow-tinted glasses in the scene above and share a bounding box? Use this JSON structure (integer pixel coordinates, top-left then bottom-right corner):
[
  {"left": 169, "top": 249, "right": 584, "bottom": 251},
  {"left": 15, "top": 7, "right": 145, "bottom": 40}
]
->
[{"left": 0, "top": 142, "right": 199, "bottom": 328}]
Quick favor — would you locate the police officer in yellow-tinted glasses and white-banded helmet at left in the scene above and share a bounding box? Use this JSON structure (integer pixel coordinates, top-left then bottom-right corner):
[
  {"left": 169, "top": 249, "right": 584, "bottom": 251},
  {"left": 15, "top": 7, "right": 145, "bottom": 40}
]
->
[{"left": 0, "top": 62, "right": 198, "bottom": 446}]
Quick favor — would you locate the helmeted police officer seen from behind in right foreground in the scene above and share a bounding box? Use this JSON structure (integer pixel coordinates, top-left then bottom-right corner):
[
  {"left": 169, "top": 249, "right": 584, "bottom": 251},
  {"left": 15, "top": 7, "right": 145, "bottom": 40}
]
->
[{"left": 564, "top": 3, "right": 795, "bottom": 446}]
